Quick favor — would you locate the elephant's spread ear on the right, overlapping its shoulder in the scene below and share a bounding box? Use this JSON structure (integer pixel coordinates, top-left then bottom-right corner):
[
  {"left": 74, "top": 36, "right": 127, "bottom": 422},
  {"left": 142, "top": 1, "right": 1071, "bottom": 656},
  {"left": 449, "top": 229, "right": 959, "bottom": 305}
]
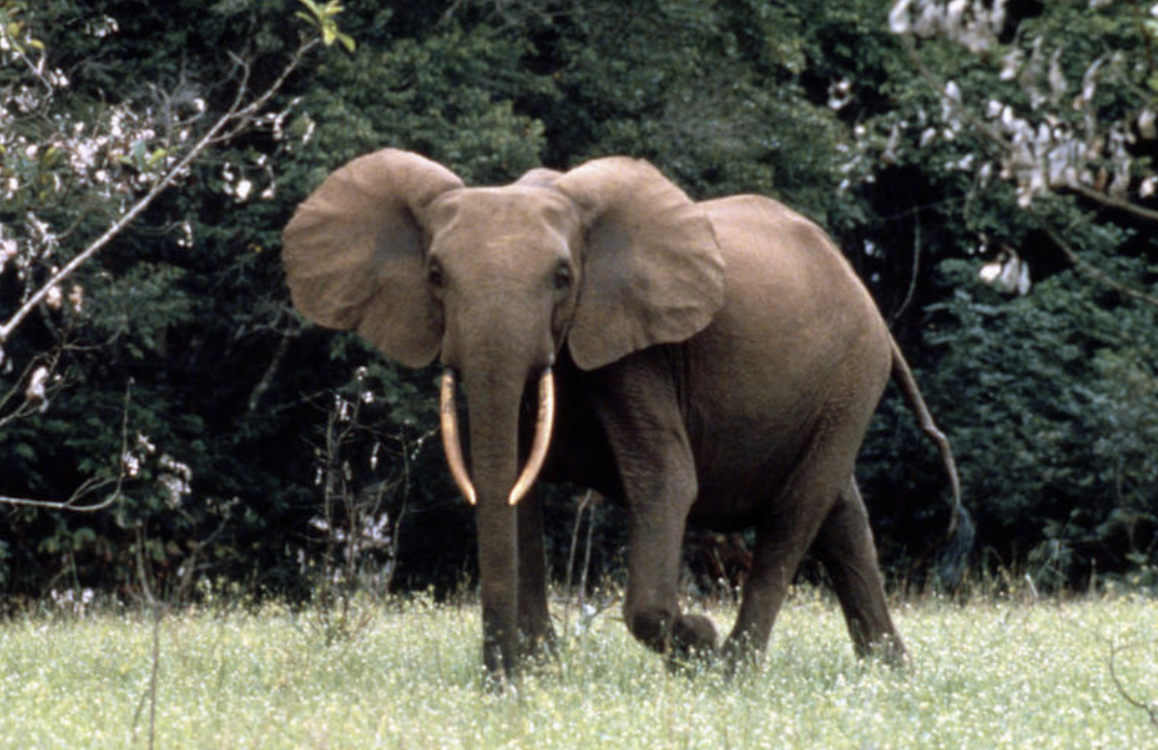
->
[{"left": 554, "top": 156, "right": 724, "bottom": 369}]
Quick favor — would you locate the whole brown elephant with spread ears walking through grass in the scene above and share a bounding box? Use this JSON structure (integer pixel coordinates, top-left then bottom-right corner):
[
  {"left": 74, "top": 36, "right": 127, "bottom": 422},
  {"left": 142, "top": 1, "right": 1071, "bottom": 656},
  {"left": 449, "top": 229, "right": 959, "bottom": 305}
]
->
[{"left": 283, "top": 148, "right": 972, "bottom": 681}]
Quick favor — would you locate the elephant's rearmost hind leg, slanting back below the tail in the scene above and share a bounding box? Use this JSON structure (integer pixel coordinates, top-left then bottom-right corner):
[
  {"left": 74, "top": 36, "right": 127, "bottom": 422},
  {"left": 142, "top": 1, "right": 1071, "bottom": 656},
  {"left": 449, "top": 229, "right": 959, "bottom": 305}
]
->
[{"left": 813, "top": 477, "right": 906, "bottom": 664}]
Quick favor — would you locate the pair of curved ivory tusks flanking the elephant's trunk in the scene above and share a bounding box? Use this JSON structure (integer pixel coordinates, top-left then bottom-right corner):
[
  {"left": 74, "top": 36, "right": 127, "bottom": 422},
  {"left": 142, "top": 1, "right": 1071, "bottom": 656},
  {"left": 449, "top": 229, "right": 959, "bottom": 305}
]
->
[{"left": 439, "top": 367, "right": 555, "bottom": 505}]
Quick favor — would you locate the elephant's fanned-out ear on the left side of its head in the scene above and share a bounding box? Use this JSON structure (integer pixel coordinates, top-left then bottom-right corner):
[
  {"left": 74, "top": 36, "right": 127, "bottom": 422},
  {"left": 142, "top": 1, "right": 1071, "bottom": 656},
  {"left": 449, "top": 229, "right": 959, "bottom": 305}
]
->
[{"left": 283, "top": 148, "right": 462, "bottom": 367}]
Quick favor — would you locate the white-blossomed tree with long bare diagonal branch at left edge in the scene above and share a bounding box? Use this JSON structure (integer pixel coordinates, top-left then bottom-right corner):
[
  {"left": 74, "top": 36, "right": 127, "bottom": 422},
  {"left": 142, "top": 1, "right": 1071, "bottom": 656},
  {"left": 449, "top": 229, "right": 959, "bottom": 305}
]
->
[{"left": 0, "top": 0, "right": 349, "bottom": 592}]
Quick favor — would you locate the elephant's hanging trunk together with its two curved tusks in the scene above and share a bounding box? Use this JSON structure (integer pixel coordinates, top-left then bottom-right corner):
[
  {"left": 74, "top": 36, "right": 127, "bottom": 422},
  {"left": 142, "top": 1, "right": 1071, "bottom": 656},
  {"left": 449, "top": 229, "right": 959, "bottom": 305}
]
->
[{"left": 441, "top": 365, "right": 555, "bottom": 674}]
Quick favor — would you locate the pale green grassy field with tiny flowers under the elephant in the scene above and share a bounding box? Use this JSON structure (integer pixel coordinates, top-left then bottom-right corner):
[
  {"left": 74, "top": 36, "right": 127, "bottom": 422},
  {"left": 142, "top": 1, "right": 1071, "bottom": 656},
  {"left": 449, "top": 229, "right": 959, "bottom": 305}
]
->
[{"left": 0, "top": 589, "right": 1158, "bottom": 750}]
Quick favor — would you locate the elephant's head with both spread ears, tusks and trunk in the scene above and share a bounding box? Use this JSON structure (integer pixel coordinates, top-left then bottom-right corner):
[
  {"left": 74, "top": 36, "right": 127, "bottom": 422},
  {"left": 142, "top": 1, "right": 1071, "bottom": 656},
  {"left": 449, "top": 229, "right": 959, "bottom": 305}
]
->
[{"left": 284, "top": 149, "right": 724, "bottom": 667}]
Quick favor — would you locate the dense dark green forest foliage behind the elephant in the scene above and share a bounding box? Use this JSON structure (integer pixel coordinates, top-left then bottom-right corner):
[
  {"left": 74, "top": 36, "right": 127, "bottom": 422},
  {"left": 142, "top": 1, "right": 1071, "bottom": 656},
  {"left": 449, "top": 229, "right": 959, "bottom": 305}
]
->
[{"left": 0, "top": 0, "right": 1158, "bottom": 596}]
